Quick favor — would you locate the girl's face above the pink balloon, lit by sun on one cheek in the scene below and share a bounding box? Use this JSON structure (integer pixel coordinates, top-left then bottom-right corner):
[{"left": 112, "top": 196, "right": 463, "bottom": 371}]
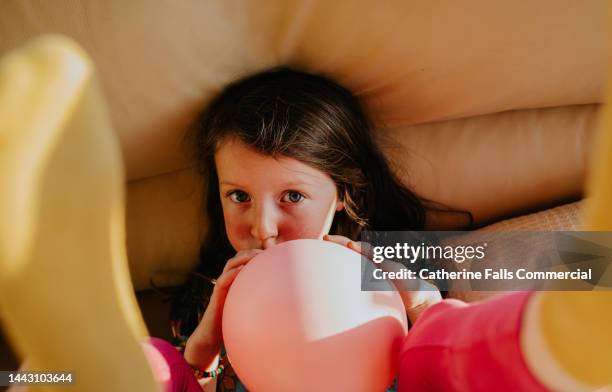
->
[{"left": 215, "top": 140, "right": 343, "bottom": 251}]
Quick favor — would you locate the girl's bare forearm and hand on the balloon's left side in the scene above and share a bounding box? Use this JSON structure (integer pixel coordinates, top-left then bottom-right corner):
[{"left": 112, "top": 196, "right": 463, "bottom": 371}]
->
[{"left": 184, "top": 249, "right": 263, "bottom": 370}]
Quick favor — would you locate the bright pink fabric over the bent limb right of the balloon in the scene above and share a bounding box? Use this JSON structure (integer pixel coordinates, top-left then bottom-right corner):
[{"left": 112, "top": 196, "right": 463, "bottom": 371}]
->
[{"left": 398, "top": 292, "right": 546, "bottom": 392}]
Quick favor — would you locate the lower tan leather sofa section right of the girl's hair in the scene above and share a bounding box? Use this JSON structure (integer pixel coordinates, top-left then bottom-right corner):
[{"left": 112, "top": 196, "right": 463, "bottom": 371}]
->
[{"left": 379, "top": 105, "right": 599, "bottom": 228}]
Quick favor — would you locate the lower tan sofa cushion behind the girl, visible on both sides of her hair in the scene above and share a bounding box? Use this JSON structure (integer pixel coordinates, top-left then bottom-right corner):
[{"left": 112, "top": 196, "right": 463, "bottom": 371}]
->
[{"left": 127, "top": 105, "right": 599, "bottom": 288}]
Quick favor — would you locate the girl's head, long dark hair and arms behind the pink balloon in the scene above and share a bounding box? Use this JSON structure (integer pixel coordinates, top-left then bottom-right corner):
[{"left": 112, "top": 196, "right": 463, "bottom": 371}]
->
[{"left": 160, "top": 68, "right": 440, "bottom": 390}]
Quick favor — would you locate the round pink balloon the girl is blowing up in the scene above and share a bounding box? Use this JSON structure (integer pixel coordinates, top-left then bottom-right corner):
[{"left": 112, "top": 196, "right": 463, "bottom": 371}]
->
[{"left": 223, "top": 240, "right": 408, "bottom": 392}]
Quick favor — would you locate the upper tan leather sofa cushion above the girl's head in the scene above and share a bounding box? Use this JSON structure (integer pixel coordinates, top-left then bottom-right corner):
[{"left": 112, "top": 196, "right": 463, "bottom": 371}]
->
[{"left": 0, "top": 0, "right": 608, "bottom": 179}]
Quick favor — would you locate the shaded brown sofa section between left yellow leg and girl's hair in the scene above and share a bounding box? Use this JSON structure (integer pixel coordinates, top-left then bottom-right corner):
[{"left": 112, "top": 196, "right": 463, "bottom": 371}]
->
[{"left": 126, "top": 170, "right": 204, "bottom": 288}]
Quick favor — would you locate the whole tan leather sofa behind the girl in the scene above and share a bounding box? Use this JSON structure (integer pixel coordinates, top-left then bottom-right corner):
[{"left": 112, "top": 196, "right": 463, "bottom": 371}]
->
[{"left": 0, "top": 0, "right": 609, "bottom": 380}]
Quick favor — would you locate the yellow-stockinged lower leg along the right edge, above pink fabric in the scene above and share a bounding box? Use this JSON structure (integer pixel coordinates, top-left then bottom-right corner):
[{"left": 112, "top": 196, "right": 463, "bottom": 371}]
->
[{"left": 522, "top": 29, "right": 612, "bottom": 391}]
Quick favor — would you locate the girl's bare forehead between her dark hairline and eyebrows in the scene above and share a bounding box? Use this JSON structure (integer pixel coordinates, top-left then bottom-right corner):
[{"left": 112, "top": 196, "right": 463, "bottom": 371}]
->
[{"left": 215, "top": 139, "right": 332, "bottom": 185}]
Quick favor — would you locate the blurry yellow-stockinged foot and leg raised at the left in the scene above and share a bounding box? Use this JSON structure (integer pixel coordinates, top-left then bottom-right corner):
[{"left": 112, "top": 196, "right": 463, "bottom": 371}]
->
[{"left": 0, "top": 36, "right": 158, "bottom": 391}]
